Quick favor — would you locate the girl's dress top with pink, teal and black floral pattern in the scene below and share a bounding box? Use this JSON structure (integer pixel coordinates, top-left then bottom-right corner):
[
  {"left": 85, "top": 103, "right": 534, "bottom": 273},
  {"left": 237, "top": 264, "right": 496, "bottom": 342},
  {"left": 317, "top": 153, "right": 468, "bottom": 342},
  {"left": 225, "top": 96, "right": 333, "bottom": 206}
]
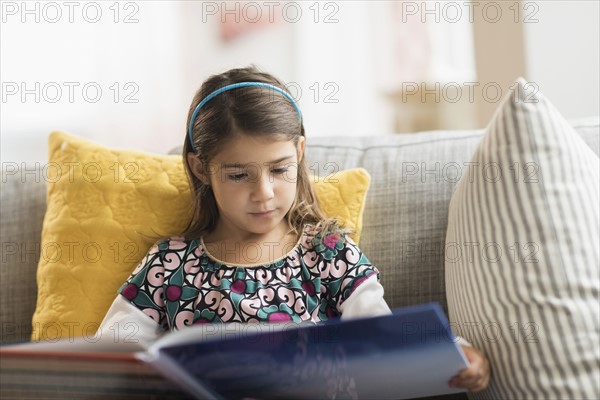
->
[{"left": 119, "top": 225, "right": 379, "bottom": 331}]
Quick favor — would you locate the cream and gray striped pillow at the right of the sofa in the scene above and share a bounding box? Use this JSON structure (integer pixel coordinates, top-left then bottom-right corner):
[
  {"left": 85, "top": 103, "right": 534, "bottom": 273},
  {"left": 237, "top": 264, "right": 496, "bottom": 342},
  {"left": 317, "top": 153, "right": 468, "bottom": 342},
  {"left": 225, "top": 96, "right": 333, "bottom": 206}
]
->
[{"left": 445, "top": 78, "right": 600, "bottom": 399}]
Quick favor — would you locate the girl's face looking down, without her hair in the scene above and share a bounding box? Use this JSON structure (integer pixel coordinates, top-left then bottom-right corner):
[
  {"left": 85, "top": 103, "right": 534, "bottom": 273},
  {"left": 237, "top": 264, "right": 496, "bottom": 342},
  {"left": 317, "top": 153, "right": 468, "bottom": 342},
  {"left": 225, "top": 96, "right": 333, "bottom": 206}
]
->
[{"left": 192, "top": 134, "right": 304, "bottom": 241}]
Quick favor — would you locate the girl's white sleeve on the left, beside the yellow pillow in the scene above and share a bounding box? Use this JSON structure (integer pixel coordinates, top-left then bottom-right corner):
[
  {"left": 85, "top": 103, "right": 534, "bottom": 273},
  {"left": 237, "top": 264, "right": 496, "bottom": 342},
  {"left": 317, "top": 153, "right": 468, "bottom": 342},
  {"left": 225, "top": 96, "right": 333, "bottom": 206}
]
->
[{"left": 98, "top": 295, "right": 163, "bottom": 348}]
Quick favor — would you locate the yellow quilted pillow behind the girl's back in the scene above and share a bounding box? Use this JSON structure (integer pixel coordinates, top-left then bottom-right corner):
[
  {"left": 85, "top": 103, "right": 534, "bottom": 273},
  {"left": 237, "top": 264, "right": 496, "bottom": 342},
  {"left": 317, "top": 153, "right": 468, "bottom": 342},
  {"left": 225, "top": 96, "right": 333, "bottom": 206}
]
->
[{"left": 32, "top": 131, "right": 370, "bottom": 340}]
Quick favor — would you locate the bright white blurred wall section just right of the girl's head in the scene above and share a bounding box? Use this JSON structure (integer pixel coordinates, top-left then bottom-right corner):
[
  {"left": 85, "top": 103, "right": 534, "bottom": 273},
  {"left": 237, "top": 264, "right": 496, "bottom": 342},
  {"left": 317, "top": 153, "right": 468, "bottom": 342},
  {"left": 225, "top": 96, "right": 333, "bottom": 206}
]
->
[{"left": 294, "top": 1, "right": 391, "bottom": 137}]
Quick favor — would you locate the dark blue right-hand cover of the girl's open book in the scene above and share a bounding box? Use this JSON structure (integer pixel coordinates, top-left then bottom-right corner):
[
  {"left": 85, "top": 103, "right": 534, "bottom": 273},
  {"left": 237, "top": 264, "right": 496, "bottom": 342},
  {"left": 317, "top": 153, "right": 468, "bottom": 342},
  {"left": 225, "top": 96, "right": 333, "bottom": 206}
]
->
[{"left": 143, "top": 303, "right": 468, "bottom": 399}]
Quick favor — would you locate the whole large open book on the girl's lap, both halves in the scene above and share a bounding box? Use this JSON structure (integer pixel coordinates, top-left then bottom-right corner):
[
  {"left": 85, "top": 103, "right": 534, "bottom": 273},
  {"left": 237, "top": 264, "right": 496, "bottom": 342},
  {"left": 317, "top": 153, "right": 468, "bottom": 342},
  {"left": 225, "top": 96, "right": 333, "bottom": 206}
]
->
[{"left": 0, "top": 303, "right": 468, "bottom": 399}]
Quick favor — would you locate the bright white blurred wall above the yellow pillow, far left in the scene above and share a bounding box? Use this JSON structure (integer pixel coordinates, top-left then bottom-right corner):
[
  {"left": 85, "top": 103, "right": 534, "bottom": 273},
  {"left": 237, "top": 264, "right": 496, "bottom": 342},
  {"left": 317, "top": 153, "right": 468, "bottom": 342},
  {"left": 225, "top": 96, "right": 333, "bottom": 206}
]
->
[{"left": 0, "top": 2, "right": 188, "bottom": 162}]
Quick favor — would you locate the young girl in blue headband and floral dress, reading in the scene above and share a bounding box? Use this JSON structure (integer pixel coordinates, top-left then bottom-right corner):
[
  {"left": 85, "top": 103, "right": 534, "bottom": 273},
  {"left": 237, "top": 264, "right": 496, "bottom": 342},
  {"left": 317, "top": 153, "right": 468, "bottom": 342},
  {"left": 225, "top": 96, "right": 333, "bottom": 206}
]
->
[{"left": 100, "top": 66, "right": 489, "bottom": 391}]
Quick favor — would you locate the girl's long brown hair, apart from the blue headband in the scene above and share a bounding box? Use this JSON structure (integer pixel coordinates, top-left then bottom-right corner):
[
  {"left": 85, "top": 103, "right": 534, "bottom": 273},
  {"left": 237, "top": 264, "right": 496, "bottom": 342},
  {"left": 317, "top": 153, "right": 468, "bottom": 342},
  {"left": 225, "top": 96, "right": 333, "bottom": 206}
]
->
[{"left": 181, "top": 65, "right": 337, "bottom": 239}]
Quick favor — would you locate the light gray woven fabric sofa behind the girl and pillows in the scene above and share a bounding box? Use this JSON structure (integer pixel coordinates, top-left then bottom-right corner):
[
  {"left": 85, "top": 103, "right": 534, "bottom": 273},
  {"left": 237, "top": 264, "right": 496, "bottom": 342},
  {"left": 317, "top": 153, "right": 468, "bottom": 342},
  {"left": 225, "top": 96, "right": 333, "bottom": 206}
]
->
[{"left": 0, "top": 118, "right": 600, "bottom": 398}]
